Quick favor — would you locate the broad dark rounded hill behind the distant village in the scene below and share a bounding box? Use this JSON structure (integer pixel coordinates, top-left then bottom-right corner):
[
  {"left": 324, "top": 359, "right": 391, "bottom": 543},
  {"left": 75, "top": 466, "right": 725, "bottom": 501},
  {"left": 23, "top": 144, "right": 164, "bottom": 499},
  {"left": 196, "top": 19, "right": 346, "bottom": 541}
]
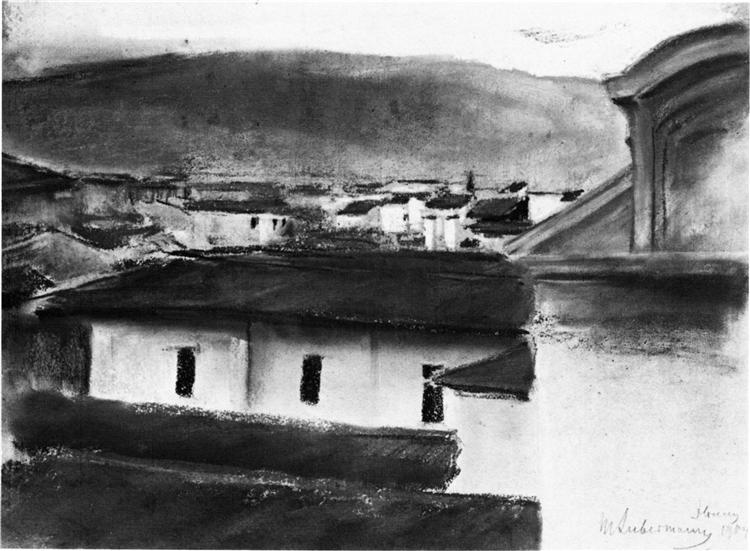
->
[{"left": 3, "top": 52, "right": 627, "bottom": 189}]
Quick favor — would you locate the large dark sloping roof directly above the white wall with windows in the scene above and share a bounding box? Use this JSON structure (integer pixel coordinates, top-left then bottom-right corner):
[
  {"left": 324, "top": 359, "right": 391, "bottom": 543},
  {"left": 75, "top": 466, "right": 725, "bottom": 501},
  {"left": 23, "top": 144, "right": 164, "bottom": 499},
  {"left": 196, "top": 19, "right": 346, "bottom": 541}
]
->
[{"left": 42, "top": 251, "right": 533, "bottom": 332}]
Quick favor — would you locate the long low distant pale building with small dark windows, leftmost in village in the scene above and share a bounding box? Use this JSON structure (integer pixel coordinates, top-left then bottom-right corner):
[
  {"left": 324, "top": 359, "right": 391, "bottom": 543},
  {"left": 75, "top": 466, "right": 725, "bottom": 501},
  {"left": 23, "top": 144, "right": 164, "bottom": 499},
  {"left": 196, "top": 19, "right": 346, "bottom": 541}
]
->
[{"left": 184, "top": 201, "right": 293, "bottom": 248}]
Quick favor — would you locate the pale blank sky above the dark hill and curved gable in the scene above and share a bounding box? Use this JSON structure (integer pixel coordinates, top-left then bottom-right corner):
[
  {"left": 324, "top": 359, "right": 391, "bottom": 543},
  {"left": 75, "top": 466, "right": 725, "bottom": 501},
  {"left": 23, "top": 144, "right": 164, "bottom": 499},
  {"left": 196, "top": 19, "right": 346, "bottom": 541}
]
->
[{"left": 3, "top": 0, "right": 747, "bottom": 79}]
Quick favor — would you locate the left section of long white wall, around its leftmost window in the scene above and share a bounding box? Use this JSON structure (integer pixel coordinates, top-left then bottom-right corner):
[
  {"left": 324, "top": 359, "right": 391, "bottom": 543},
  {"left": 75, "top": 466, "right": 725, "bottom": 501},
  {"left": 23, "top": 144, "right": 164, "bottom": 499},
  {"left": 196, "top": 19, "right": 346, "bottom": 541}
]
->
[{"left": 89, "top": 321, "right": 248, "bottom": 411}]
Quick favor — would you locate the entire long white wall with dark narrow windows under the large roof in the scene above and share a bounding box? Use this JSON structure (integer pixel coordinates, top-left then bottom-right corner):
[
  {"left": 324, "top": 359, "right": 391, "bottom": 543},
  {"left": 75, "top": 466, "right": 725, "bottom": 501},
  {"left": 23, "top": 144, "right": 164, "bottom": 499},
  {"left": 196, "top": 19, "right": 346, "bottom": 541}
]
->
[{"left": 90, "top": 320, "right": 504, "bottom": 427}]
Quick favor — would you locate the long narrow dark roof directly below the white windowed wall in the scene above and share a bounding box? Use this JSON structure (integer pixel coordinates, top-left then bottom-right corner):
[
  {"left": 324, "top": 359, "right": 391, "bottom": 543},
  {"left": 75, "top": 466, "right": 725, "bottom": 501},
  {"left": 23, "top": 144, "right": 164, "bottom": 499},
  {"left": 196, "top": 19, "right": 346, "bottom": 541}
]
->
[{"left": 4, "top": 391, "right": 459, "bottom": 489}]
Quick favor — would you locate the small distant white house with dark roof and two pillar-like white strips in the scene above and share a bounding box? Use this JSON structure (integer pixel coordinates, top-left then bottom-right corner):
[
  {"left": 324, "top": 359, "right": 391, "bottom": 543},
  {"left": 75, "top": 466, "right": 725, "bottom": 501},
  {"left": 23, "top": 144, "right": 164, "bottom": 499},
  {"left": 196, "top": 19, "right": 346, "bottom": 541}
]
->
[{"left": 423, "top": 194, "right": 472, "bottom": 251}]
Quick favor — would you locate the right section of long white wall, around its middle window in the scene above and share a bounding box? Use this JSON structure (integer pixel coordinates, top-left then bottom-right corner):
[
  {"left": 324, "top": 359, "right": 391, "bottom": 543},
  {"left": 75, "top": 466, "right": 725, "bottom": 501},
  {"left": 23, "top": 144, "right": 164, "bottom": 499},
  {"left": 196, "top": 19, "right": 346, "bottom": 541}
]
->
[{"left": 249, "top": 323, "right": 503, "bottom": 427}]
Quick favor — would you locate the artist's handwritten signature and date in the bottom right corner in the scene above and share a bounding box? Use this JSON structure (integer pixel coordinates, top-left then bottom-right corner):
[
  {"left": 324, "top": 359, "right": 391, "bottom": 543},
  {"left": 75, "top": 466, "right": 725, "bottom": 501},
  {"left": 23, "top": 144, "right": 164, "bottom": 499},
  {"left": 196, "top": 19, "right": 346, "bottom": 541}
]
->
[{"left": 599, "top": 503, "right": 747, "bottom": 549}]
